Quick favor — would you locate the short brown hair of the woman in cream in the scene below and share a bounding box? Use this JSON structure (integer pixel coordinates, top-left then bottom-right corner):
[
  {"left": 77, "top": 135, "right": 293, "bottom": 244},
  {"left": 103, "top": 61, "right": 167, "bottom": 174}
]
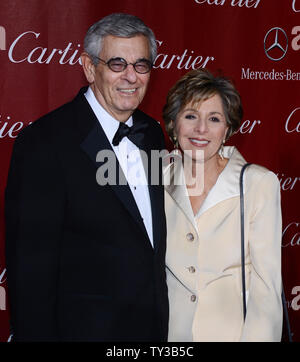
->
[{"left": 163, "top": 69, "right": 243, "bottom": 142}]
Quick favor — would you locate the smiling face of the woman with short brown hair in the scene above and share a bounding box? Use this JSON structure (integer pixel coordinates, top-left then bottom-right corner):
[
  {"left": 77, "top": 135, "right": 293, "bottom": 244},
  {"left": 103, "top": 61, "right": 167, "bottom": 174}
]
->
[{"left": 175, "top": 94, "right": 228, "bottom": 162}]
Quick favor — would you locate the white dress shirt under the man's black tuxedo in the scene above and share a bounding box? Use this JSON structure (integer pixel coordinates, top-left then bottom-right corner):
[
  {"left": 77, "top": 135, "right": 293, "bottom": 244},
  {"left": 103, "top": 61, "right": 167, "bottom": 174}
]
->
[{"left": 85, "top": 87, "right": 153, "bottom": 247}]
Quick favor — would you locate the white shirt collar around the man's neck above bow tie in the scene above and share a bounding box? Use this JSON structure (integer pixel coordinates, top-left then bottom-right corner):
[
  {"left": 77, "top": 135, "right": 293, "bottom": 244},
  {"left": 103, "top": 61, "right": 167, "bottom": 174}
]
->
[{"left": 84, "top": 87, "right": 133, "bottom": 144}]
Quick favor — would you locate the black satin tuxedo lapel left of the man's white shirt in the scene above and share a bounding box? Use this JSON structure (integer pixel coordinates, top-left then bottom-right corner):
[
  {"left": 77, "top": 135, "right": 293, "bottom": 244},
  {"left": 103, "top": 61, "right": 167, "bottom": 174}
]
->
[{"left": 75, "top": 90, "right": 148, "bottom": 243}]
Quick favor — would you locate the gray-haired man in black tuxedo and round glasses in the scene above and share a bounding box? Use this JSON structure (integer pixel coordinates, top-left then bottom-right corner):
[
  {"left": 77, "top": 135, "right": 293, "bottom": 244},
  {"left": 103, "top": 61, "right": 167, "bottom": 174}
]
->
[{"left": 6, "top": 14, "right": 168, "bottom": 341}]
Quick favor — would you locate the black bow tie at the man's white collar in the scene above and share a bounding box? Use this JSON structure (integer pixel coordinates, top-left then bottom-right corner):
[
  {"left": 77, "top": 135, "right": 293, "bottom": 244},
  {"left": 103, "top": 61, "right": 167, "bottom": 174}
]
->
[{"left": 112, "top": 121, "right": 148, "bottom": 148}]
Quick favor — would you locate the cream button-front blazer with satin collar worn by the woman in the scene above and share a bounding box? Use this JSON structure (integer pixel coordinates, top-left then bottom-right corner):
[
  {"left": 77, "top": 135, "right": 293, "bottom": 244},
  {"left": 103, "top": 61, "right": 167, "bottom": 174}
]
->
[{"left": 164, "top": 147, "right": 282, "bottom": 342}]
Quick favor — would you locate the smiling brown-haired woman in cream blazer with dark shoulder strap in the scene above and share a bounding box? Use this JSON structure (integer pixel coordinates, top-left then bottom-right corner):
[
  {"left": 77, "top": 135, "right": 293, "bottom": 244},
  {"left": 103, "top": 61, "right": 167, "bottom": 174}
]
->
[{"left": 163, "top": 70, "right": 282, "bottom": 341}]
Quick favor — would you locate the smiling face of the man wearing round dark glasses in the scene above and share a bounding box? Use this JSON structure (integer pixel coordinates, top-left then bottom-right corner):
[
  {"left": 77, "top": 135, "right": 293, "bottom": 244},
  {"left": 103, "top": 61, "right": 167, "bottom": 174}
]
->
[{"left": 83, "top": 35, "right": 150, "bottom": 122}]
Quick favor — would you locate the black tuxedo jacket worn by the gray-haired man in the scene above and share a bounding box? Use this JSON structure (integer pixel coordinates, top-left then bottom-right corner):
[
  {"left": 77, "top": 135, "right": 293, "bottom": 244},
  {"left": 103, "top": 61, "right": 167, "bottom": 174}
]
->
[{"left": 5, "top": 88, "right": 168, "bottom": 341}]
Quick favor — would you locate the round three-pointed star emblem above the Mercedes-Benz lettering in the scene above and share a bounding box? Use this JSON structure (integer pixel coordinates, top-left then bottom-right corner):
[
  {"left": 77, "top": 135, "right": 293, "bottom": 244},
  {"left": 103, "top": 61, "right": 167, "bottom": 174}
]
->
[{"left": 264, "top": 27, "right": 288, "bottom": 61}]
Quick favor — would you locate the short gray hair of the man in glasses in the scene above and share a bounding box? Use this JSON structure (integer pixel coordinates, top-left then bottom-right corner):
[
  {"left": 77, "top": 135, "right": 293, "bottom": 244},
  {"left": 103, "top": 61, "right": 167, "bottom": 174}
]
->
[{"left": 84, "top": 13, "right": 157, "bottom": 65}]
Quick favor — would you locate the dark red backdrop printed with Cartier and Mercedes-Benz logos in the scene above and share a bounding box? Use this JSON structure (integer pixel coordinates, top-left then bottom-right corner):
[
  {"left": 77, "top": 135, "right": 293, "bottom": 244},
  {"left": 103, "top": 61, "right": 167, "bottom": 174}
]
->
[{"left": 0, "top": 0, "right": 300, "bottom": 341}]
